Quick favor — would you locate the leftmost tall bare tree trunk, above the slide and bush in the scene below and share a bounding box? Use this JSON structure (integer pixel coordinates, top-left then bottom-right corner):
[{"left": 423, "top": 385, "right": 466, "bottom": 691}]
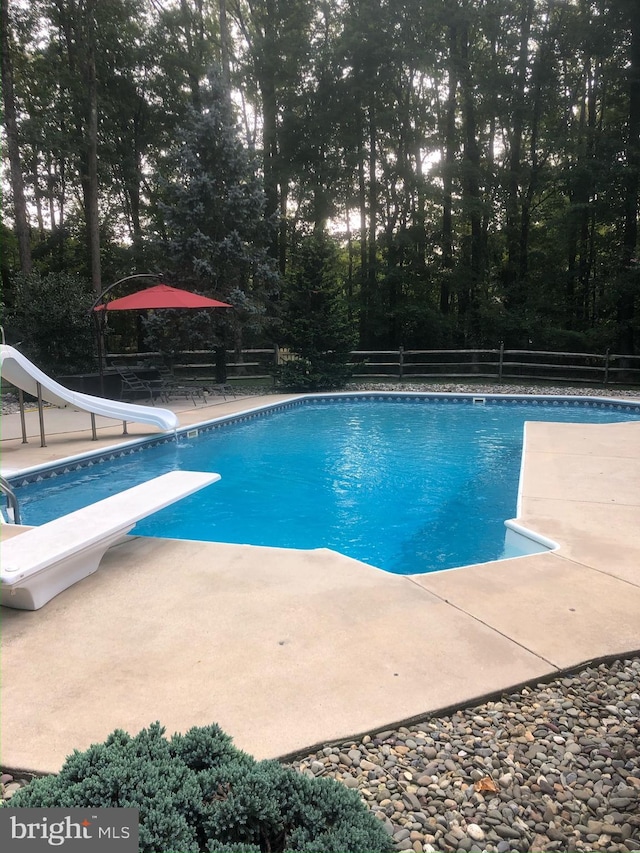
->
[{"left": 0, "top": 0, "right": 31, "bottom": 273}]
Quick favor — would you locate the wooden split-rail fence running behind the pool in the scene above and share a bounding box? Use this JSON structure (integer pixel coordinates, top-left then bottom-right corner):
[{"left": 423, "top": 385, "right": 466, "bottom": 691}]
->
[{"left": 108, "top": 346, "right": 640, "bottom": 386}]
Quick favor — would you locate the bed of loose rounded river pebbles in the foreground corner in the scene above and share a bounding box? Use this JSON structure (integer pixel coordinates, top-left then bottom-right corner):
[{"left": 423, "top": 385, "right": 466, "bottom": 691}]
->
[{"left": 292, "top": 657, "right": 640, "bottom": 853}]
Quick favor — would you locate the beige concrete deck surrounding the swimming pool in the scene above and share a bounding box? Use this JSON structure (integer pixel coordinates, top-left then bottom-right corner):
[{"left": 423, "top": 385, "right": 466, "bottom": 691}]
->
[{"left": 0, "top": 396, "right": 640, "bottom": 772}]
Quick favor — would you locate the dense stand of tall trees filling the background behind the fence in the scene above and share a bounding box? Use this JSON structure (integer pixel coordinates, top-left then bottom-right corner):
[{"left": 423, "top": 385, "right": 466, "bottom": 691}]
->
[{"left": 2, "top": 0, "right": 640, "bottom": 372}]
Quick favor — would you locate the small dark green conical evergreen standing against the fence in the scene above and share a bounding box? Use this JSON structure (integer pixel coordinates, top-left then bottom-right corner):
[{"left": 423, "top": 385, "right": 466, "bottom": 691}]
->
[{"left": 276, "top": 234, "right": 356, "bottom": 391}]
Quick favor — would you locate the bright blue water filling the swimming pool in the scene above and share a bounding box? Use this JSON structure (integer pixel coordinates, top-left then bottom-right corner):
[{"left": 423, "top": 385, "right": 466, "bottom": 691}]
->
[{"left": 8, "top": 397, "right": 640, "bottom": 574}]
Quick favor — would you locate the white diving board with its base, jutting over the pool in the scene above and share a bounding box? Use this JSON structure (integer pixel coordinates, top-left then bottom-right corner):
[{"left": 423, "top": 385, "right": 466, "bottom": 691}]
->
[{"left": 0, "top": 471, "right": 220, "bottom": 610}]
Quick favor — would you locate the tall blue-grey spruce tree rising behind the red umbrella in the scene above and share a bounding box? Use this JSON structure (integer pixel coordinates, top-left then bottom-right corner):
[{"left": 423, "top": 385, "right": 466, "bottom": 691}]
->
[{"left": 159, "top": 75, "right": 279, "bottom": 346}]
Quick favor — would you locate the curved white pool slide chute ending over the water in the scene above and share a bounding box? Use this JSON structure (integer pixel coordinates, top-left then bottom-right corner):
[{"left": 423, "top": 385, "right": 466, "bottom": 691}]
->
[{"left": 0, "top": 344, "right": 179, "bottom": 432}]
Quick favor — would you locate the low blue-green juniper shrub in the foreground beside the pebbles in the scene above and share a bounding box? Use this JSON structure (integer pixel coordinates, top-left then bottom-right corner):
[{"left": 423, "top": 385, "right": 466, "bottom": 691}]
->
[{"left": 7, "top": 723, "right": 393, "bottom": 853}]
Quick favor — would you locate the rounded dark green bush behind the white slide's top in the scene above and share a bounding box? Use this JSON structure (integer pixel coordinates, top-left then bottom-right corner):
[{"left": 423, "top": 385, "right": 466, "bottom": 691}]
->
[{"left": 4, "top": 273, "right": 95, "bottom": 374}]
